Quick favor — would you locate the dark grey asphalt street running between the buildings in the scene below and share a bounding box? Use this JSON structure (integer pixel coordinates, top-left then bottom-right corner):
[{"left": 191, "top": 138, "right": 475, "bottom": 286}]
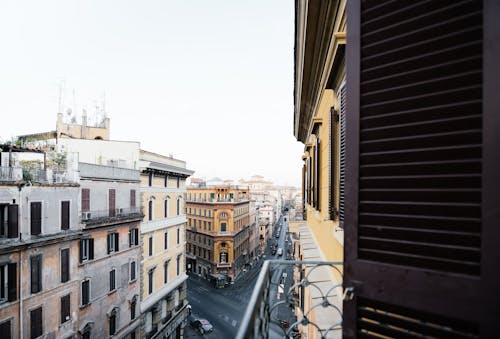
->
[{"left": 185, "top": 214, "right": 293, "bottom": 339}]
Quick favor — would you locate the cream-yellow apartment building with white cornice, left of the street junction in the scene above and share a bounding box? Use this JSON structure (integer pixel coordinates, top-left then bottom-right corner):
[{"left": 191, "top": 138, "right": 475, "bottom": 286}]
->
[{"left": 140, "top": 150, "right": 194, "bottom": 338}]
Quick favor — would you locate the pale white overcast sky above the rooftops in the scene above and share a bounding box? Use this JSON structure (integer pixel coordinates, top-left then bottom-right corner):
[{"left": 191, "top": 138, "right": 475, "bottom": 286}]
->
[{"left": 0, "top": 0, "right": 303, "bottom": 187}]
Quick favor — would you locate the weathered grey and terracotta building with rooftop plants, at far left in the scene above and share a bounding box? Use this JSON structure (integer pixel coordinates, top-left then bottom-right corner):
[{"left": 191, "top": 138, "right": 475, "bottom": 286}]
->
[{"left": 0, "top": 145, "right": 81, "bottom": 339}]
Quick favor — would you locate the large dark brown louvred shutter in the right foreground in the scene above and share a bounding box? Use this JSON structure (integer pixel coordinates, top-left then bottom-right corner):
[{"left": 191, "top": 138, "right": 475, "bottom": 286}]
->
[{"left": 343, "top": 0, "right": 500, "bottom": 338}]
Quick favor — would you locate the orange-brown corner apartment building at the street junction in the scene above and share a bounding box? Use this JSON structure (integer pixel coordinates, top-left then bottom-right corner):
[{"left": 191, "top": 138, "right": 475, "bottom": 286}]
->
[{"left": 186, "top": 185, "right": 250, "bottom": 281}]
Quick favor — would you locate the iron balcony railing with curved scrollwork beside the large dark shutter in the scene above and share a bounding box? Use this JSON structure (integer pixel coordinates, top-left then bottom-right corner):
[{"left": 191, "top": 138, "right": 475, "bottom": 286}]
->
[{"left": 236, "top": 260, "right": 345, "bottom": 339}]
